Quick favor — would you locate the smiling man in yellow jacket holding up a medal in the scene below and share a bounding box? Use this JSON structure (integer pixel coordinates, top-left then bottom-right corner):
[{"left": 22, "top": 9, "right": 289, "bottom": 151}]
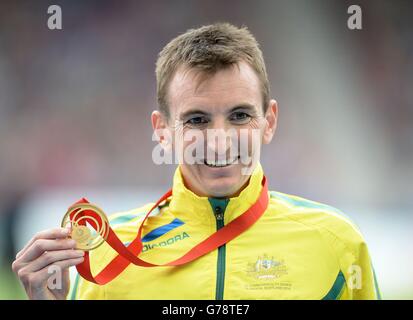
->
[{"left": 13, "top": 24, "right": 380, "bottom": 299}]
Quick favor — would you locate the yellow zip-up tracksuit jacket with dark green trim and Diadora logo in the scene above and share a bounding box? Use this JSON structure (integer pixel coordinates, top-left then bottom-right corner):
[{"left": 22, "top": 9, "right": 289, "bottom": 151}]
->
[{"left": 68, "top": 164, "right": 380, "bottom": 299}]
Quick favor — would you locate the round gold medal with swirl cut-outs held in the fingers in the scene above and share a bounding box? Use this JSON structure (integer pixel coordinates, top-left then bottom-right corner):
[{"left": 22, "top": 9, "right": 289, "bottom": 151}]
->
[{"left": 61, "top": 203, "right": 109, "bottom": 251}]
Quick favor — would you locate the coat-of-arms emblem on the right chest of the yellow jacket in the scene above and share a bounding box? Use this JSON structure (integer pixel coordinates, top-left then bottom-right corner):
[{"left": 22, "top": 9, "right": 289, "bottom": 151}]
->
[{"left": 247, "top": 254, "right": 288, "bottom": 280}]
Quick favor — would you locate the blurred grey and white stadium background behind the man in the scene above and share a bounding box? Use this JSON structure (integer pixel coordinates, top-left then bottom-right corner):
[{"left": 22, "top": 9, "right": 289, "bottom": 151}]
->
[{"left": 0, "top": 0, "right": 413, "bottom": 299}]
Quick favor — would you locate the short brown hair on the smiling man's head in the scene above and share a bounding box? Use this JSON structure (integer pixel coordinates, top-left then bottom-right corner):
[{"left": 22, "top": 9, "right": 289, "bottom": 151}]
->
[{"left": 156, "top": 23, "right": 269, "bottom": 117}]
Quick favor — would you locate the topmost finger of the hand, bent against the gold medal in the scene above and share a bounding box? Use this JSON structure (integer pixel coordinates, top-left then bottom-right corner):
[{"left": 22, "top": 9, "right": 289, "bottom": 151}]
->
[{"left": 18, "top": 239, "right": 76, "bottom": 263}]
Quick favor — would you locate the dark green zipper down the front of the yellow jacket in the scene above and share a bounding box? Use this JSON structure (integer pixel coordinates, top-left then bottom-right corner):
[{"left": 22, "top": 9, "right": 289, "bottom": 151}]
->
[{"left": 208, "top": 198, "right": 229, "bottom": 300}]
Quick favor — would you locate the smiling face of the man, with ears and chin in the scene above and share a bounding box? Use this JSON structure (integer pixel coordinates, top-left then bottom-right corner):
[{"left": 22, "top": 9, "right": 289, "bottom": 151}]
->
[{"left": 152, "top": 62, "right": 277, "bottom": 197}]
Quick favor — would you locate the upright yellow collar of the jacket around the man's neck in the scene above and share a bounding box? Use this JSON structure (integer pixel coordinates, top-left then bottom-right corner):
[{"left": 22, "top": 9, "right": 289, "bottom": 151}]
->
[{"left": 169, "top": 163, "right": 264, "bottom": 229}]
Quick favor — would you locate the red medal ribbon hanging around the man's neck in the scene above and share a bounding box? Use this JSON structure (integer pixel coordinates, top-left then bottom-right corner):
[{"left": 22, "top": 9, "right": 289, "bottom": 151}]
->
[{"left": 69, "top": 177, "right": 268, "bottom": 285}]
